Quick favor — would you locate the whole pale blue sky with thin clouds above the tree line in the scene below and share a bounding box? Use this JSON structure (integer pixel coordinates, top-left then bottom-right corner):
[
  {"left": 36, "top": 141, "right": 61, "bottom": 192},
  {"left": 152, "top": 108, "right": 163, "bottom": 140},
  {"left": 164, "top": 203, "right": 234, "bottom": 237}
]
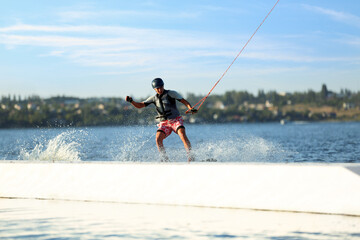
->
[{"left": 0, "top": 0, "right": 360, "bottom": 98}]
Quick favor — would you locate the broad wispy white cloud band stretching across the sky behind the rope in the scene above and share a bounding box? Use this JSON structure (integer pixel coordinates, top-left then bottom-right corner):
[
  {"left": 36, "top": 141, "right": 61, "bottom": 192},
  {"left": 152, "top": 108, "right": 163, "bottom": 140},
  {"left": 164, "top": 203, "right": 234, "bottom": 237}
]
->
[{"left": 0, "top": 21, "right": 359, "bottom": 72}]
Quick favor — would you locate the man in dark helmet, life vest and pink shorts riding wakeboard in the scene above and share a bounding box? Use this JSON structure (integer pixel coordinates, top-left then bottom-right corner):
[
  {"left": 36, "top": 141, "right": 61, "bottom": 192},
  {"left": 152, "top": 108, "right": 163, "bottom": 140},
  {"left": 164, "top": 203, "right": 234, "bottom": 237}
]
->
[{"left": 125, "top": 78, "right": 197, "bottom": 162}]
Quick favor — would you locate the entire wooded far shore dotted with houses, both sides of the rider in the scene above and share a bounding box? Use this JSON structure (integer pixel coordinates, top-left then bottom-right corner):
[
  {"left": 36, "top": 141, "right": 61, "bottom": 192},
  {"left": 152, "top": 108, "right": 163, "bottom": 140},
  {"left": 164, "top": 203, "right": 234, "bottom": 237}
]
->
[{"left": 0, "top": 85, "right": 360, "bottom": 128}]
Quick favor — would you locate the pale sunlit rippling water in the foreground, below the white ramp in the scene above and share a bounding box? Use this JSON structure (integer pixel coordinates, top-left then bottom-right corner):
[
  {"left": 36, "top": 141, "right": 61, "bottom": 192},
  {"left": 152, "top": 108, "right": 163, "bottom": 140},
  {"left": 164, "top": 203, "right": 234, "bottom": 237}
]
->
[{"left": 0, "top": 199, "right": 360, "bottom": 240}]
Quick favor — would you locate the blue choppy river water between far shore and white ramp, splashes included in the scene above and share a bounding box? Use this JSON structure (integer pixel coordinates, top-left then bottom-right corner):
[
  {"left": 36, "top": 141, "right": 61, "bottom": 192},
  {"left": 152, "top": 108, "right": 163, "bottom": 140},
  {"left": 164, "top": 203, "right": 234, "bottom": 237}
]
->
[{"left": 0, "top": 122, "right": 360, "bottom": 163}]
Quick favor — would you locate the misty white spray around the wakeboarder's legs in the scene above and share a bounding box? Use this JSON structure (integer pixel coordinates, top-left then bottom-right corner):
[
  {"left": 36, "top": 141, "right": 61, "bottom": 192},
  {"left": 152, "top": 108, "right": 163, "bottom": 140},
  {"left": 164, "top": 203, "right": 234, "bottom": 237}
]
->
[{"left": 114, "top": 136, "right": 291, "bottom": 162}]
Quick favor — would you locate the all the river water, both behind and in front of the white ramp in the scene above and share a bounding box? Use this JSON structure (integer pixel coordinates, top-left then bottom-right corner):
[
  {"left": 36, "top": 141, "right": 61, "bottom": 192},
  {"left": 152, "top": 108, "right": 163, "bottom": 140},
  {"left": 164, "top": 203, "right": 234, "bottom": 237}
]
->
[{"left": 0, "top": 122, "right": 360, "bottom": 240}]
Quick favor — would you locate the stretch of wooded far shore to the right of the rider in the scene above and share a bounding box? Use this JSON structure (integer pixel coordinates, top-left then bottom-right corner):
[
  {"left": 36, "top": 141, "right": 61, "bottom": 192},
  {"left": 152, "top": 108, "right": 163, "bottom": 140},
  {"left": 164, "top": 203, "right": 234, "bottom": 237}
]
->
[{"left": 188, "top": 84, "right": 360, "bottom": 122}]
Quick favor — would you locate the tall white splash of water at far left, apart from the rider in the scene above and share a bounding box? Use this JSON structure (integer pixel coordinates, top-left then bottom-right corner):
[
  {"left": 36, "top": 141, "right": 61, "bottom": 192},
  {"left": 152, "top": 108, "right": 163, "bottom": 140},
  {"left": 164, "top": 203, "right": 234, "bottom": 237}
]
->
[{"left": 19, "top": 131, "right": 81, "bottom": 162}]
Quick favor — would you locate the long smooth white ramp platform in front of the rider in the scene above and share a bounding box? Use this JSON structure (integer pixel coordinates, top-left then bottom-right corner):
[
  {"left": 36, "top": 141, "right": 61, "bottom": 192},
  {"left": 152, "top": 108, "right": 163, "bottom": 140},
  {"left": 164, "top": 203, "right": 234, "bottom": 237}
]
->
[{"left": 0, "top": 161, "right": 360, "bottom": 216}]
